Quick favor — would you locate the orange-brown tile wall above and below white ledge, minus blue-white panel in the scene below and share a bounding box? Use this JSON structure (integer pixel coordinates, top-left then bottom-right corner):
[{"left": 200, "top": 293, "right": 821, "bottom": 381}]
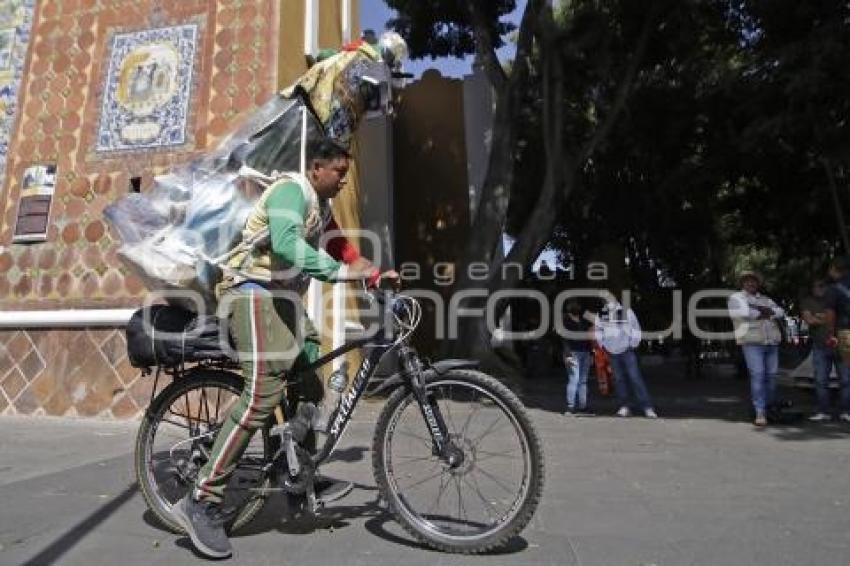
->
[{"left": 0, "top": 0, "right": 278, "bottom": 418}]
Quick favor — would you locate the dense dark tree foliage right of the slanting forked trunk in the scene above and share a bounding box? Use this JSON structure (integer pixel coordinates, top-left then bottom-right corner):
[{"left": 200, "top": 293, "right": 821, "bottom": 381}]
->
[{"left": 548, "top": 2, "right": 850, "bottom": 310}]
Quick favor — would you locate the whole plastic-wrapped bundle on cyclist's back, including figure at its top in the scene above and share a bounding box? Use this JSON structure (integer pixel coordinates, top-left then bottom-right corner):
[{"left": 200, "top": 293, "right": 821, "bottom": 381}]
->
[{"left": 104, "top": 38, "right": 400, "bottom": 311}]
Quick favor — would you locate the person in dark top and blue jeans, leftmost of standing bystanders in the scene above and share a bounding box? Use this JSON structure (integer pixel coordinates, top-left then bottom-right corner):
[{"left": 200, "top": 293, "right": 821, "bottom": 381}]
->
[{"left": 563, "top": 300, "right": 593, "bottom": 415}]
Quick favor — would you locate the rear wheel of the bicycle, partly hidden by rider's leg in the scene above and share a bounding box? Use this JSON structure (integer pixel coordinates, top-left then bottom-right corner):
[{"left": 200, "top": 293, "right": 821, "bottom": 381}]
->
[{"left": 135, "top": 370, "right": 273, "bottom": 533}]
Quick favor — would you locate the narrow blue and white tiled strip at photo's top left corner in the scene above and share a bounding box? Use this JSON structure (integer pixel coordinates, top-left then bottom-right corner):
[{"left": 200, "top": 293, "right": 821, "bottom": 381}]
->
[{"left": 0, "top": 0, "right": 35, "bottom": 188}]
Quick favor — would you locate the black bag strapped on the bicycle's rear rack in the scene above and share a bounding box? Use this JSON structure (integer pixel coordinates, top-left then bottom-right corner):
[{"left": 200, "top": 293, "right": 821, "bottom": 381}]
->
[{"left": 127, "top": 305, "right": 230, "bottom": 368}]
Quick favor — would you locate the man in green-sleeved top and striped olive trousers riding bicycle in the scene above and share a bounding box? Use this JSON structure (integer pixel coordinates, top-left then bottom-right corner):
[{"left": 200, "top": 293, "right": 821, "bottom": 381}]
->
[{"left": 174, "top": 139, "right": 398, "bottom": 558}]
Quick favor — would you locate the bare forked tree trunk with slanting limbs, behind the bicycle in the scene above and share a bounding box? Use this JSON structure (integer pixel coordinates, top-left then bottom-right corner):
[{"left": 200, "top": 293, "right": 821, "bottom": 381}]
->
[{"left": 448, "top": 0, "right": 657, "bottom": 364}]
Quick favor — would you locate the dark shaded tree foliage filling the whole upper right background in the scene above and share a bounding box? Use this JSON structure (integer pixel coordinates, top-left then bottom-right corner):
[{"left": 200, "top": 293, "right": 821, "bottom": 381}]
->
[{"left": 387, "top": 0, "right": 850, "bottom": 356}]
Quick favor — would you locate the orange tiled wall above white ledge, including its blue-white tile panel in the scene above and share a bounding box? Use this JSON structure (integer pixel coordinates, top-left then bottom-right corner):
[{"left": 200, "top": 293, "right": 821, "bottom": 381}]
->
[{"left": 0, "top": 0, "right": 276, "bottom": 310}]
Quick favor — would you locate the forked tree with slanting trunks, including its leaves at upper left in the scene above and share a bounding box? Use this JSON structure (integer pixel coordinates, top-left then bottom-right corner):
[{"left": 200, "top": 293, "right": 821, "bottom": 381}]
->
[{"left": 387, "top": 0, "right": 662, "bottom": 362}]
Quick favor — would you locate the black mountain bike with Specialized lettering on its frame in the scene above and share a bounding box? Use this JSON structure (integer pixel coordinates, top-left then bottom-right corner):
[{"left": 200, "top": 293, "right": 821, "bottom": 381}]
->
[{"left": 135, "top": 293, "right": 544, "bottom": 554}]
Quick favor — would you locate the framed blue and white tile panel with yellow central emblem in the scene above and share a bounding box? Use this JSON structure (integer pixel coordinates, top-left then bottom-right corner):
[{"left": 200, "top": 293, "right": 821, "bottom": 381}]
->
[{"left": 95, "top": 24, "right": 198, "bottom": 152}]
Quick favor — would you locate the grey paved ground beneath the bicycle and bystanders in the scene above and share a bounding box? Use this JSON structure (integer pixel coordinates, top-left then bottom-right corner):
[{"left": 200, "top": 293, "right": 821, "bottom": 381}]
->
[{"left": 0, "top": 366, "right": 850, "bottom": 566}]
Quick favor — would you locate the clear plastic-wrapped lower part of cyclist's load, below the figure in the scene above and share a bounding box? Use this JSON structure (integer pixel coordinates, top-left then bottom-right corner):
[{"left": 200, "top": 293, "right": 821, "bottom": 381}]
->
[{"left": 104, "top": 97, "right": 324, "bottom": 310}]
